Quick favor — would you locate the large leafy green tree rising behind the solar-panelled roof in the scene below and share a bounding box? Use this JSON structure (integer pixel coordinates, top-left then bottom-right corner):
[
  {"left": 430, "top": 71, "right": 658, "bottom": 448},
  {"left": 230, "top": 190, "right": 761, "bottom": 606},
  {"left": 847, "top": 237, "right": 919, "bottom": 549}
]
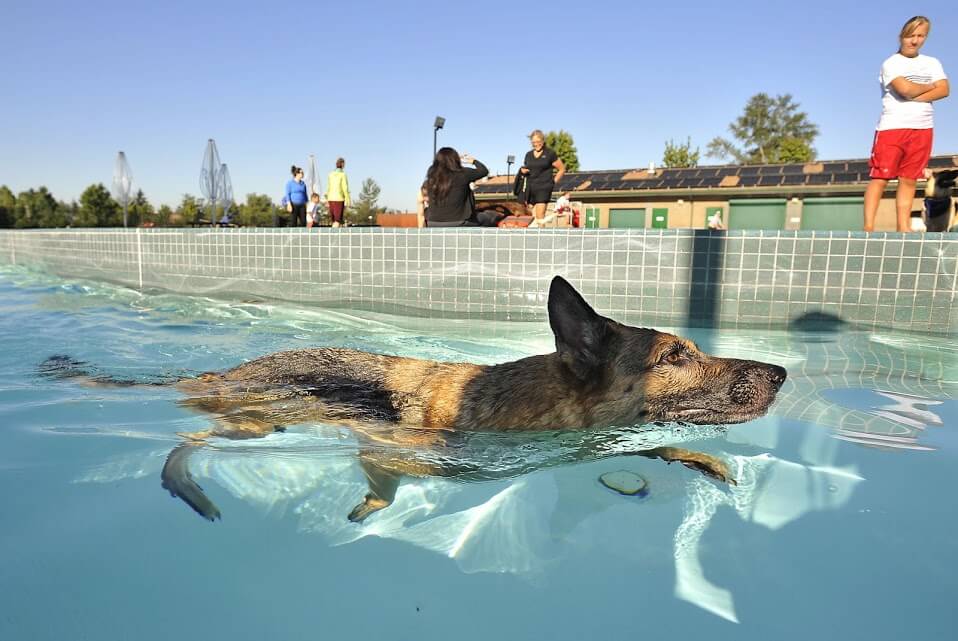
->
[{"left": 707, "top": 93, "right": 818, "bottom": 165}]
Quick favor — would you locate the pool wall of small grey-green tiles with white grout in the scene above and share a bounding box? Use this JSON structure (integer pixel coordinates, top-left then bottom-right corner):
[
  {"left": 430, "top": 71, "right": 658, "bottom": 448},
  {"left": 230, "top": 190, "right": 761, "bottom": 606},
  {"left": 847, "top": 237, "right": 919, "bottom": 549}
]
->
[{"left": 0, "top": 228, "right": 958, "bottom": 335}]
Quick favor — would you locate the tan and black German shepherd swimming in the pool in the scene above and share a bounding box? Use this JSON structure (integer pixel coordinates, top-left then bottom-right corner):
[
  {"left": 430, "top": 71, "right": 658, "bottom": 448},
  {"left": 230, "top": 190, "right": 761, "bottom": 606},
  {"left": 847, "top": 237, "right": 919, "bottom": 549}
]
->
[{"left": 41, "top": 276, "right": 786, "bottom": 522}]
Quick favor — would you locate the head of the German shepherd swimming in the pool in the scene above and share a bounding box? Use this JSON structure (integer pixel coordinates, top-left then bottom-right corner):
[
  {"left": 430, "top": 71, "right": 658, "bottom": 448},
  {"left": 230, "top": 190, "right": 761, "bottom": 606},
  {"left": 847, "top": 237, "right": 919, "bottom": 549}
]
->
[{"left": 549, "top": 276, "right": 786, "bottom": 425}]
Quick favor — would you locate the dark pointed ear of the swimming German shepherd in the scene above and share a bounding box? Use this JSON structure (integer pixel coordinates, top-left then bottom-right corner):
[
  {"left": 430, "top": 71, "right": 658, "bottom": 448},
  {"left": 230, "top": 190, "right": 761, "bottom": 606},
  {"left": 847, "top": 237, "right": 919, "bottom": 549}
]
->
[{"left": 549, "top": 276, "right": 609, "bottom": 381}]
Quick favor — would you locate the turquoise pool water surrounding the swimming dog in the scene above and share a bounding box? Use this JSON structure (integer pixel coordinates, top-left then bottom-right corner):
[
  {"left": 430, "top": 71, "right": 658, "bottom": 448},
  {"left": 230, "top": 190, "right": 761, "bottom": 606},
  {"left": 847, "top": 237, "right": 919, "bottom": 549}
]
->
[{"left": 0, "top": 268, "right": 958, "bottom": 641}]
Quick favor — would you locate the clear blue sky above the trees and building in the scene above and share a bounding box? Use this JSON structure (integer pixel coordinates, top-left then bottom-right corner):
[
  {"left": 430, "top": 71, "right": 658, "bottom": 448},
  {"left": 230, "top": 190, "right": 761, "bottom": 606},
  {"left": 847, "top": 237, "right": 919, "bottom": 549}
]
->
[{"left": 0, "top": 0, "right": 958, "bottom": 209}]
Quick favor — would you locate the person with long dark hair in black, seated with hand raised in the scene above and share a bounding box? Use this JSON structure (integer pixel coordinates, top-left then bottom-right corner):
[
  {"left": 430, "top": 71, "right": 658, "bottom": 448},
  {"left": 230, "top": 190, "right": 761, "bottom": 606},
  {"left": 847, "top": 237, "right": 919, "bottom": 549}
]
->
[{"left": 424, "top": 147, "right": 491, "bottom": 227}]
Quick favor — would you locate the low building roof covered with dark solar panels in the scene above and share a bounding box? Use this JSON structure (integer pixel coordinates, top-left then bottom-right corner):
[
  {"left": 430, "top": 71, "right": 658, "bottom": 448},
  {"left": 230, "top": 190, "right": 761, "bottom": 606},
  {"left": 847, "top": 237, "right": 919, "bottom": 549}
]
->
[{"left": 476, "top": 155, "right": 958, "bottom": 197}]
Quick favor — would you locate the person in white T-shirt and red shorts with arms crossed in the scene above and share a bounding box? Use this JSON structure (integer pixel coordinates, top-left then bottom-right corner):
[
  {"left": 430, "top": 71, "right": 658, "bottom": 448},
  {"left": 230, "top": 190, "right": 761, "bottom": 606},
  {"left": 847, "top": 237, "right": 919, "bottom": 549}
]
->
[{"left": 865, "top": 16, "right": 949, "bottom": 231}]
